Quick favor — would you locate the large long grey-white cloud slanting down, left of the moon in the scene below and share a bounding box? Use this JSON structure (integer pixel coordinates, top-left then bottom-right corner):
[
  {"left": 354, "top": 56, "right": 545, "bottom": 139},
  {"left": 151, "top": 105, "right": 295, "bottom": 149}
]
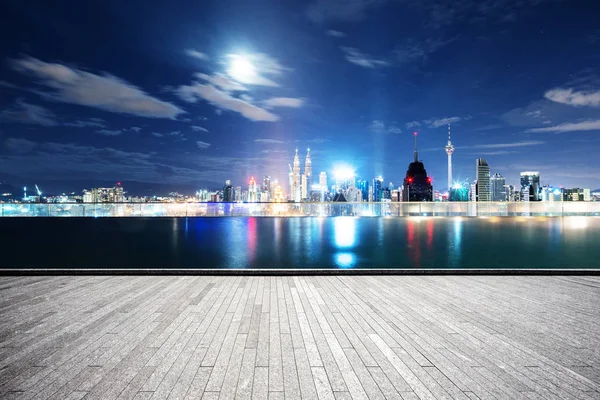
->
[{"left": 12, "top": 57, "right": 185, "bottom": 119}]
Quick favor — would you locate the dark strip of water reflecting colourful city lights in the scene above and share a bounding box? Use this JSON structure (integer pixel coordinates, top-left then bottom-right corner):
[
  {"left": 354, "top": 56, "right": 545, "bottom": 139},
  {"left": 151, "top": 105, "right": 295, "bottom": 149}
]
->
[{"left": 3, "top": 217, "right": 600, "bottom": 268}]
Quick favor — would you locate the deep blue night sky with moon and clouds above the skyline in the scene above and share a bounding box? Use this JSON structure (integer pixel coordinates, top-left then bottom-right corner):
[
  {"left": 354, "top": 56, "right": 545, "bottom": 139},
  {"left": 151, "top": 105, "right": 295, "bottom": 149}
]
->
[{"left": 0, "top": 0, "right": 600, "bottom": 192}]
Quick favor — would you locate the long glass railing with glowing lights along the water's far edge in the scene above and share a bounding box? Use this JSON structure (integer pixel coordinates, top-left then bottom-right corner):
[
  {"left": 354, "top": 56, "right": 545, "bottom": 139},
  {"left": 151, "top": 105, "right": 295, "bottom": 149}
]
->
[{"left": 0, "top": 202, "right": 600, "bottom": 217}]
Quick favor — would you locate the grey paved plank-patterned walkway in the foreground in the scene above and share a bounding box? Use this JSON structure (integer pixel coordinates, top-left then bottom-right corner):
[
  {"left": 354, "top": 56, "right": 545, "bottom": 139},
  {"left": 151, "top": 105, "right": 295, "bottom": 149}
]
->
[{"left": 0, "top": 276, "right": 600, "bottom": 400}]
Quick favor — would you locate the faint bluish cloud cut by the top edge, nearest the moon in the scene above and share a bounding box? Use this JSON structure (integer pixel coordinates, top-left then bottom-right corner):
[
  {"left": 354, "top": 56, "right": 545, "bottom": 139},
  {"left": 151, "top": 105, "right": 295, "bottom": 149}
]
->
[{"left": 306, "top": 0, "right": 386, "bottom": 24}]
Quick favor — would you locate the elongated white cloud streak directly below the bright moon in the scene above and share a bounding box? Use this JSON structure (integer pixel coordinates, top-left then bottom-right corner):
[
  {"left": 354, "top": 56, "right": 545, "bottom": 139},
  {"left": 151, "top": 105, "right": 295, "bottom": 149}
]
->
[{"left": 176, "top": 83, "right": 279, "bottom": 122}]
